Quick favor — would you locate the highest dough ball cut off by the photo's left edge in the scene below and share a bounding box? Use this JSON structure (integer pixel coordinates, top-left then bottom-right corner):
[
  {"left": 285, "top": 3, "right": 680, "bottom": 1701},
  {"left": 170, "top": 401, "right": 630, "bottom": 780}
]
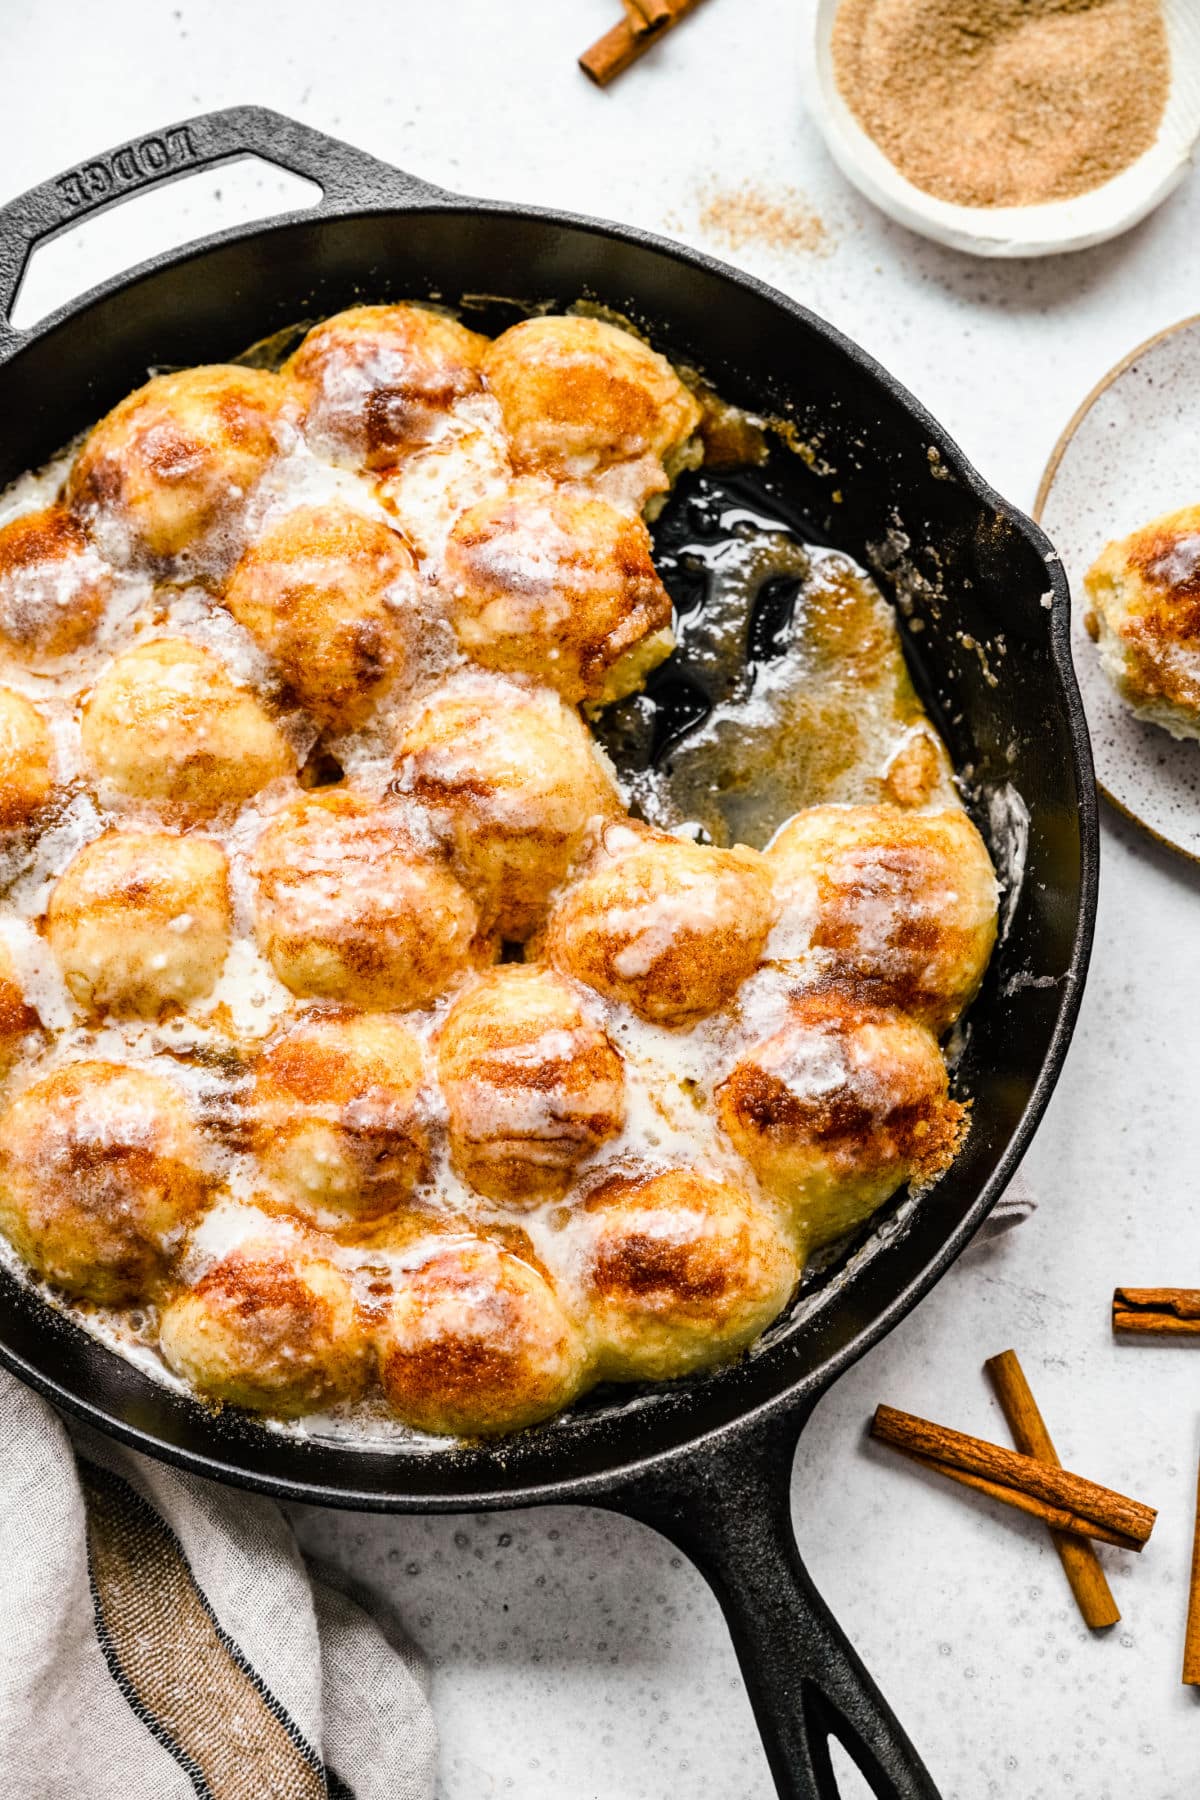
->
[{"left": 0, "top": 506, "right": 112, "bottom": 659}]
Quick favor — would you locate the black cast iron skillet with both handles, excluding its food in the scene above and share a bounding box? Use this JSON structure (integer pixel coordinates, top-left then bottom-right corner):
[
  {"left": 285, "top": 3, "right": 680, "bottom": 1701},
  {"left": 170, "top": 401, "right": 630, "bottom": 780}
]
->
[{"left": 0, "top": 106, "right": 1097, "bottom": 1800}]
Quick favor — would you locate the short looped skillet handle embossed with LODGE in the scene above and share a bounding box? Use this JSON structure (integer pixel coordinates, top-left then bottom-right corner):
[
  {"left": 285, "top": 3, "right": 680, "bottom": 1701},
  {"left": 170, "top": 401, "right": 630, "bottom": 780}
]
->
[{"left": 0, "top": 106, "right": 448, "bottom": 343}]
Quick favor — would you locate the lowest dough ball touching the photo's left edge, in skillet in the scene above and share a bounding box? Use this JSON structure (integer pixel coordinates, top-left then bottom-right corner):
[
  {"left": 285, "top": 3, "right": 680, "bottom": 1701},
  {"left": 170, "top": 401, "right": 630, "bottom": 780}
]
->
[{"left": 0, "top": 1062, "right": 209, "bottom": 1305}]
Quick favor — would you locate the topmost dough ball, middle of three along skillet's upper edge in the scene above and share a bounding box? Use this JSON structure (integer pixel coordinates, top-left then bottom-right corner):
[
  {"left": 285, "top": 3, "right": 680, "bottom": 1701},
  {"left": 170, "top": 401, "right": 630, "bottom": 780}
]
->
[{"left": 284, "top": 306, "right": 488, "bottom": 468}]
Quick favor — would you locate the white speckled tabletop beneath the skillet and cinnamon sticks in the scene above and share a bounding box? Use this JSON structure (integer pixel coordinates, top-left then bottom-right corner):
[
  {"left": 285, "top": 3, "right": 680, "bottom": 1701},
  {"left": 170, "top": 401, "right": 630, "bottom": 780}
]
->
[{"left": 0, "top": 0, "right": 1200, "bottom": 1800}]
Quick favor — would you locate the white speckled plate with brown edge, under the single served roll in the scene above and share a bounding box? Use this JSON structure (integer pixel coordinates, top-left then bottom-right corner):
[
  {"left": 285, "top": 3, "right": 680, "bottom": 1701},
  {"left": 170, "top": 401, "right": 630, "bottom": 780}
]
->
[{"left": 1033, "top": 317, "right": 1200, "bottom": 862}]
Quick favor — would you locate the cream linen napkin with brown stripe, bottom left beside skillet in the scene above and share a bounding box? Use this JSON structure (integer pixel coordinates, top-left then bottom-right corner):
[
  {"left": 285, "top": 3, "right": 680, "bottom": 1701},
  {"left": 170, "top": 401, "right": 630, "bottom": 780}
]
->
[{"left": 0, "top": 1370, "right": 437, "bottom": 1800}]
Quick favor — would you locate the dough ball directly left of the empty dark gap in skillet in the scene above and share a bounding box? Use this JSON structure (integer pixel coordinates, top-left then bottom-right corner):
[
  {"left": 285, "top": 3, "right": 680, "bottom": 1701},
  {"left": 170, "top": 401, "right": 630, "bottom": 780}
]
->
[{"left": 443, "top": 479, "right": 673, "bottom": 704}]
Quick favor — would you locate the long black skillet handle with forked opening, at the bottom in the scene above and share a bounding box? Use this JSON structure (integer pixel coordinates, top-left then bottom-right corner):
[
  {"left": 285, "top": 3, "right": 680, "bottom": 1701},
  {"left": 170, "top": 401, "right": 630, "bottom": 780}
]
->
[{"left": 604, "top": 1413, "right": 939, "bottom": 1800}]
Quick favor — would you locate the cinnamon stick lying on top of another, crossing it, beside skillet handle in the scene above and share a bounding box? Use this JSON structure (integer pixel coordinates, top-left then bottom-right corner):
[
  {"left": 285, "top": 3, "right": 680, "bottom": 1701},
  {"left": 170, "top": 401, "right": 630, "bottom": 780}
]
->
[{"left": 871, "top": 1406, "right": 1157, "bottom": 1550}]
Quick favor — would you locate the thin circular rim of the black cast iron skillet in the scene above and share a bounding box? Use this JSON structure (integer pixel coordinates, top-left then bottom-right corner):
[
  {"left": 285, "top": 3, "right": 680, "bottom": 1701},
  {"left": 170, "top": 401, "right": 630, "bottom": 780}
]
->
[{"left": 0, "top": 179, "right": 1099, "bottom": 1512}]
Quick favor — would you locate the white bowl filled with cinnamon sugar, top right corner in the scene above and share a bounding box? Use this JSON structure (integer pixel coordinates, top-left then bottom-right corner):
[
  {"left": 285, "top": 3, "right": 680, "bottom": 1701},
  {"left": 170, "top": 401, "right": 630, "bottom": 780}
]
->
[{"left": 810, "top": 0, "right": 1200, "bottom": 256}]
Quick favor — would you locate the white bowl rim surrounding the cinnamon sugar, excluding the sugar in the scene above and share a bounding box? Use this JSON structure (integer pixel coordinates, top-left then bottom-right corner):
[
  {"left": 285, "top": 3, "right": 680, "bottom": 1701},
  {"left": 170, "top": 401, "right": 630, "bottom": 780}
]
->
[{"left": 808, "top": 0, "right": 1200, "bottom": 256}]
